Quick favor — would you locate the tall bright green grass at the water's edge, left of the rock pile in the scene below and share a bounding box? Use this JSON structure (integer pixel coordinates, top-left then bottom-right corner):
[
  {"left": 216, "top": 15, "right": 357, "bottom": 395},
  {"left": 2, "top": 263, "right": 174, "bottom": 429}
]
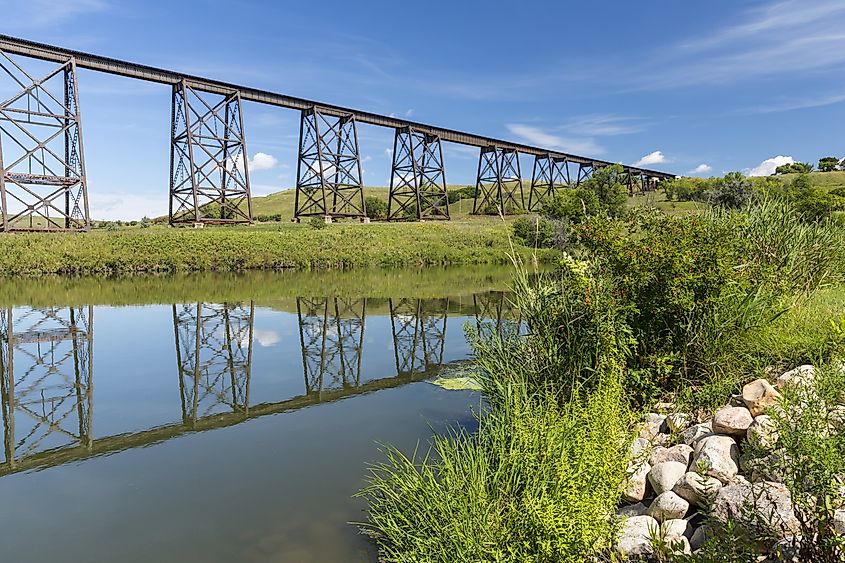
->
[{"left": 361, "top": 264, "right": 631, "bottom": 562}]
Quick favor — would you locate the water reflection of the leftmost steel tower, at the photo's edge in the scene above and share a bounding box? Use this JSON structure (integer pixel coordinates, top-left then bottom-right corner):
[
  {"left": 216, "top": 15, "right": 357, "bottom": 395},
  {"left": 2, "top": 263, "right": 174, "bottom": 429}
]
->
[{"left": 0, "top": 306, "right": 94, "bottom": 468}]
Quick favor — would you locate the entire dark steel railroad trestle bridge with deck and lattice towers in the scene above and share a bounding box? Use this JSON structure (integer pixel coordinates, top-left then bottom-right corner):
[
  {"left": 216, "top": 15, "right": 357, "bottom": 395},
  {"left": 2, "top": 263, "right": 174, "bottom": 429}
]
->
[{"left": 0, "top": 35, "right": 673, "bottom": 231}]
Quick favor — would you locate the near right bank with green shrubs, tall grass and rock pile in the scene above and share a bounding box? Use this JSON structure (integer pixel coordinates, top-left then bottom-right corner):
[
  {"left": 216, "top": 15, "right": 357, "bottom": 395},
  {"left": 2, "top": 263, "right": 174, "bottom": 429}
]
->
[{"left": 359, "top": 165, "right": 845, "bottom": 563}]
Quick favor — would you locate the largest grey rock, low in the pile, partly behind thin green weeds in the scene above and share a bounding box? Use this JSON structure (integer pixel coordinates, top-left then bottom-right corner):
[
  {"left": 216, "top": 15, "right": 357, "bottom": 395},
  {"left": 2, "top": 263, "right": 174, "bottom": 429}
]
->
[{"left": 710, "top": 481, "right": 800, "bottom": 538}]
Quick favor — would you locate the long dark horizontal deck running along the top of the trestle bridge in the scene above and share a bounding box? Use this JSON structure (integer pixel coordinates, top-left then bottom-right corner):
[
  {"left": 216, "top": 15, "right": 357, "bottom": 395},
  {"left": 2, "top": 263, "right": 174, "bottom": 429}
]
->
[{"left": 0, "top": 35, "right": 674, "bottom": 178}]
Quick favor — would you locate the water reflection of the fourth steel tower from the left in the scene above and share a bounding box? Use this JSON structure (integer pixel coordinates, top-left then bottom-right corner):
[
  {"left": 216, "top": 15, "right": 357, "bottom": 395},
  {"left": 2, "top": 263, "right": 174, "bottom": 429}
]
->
[{"left": 390, "top": 299, "right": 449, "bottom": 376}]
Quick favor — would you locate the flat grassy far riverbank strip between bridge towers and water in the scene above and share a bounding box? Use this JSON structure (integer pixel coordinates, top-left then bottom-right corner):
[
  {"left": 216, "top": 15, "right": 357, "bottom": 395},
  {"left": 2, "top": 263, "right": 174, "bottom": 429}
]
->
[{"left": 0, "top": 220, "right": 557, "bottom": 276}]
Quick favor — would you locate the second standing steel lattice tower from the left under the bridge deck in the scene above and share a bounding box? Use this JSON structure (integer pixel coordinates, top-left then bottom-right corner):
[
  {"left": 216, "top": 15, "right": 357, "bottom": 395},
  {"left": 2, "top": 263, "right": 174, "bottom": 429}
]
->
[{"left": 169, "top": 80, "right": 252, "bottom": 225}]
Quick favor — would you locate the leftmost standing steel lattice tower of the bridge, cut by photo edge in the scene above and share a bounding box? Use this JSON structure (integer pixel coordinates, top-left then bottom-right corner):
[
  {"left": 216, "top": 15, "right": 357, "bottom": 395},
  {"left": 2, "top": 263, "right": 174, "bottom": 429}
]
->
[{"left": 0, "top": 51, "right": 91, "bottom": 231}]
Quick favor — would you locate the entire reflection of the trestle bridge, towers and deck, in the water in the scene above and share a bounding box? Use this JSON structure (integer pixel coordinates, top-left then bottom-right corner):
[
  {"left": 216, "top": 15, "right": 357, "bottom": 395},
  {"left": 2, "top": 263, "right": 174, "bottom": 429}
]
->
[{"left": 0, "top": 292, "right": 520, "bottom": 476}]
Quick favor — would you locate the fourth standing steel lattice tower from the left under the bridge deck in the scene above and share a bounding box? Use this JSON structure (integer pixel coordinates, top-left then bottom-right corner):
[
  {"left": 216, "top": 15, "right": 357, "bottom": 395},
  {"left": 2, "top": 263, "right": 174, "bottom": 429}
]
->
[{"left": 387, "top": 127, "right": 449, "bottom": 221}]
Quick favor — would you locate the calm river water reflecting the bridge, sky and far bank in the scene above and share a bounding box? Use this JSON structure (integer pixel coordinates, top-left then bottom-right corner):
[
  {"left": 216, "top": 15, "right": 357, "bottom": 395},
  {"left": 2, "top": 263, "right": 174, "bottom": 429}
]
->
[{"left": 0, "top": 269, "right": 515, "bottom": 563}]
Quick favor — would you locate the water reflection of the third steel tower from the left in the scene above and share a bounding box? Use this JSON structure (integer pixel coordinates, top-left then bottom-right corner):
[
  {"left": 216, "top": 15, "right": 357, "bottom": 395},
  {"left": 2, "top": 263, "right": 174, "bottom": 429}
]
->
[{"left": 296, "top": 297, "right": 367, "bottom": 395}]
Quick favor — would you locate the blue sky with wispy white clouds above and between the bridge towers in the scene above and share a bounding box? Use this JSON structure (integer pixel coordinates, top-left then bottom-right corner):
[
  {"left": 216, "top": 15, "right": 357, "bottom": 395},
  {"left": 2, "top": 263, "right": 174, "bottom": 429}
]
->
[{"left": 0, "top": 0, "right": 845, "bottom": 218}]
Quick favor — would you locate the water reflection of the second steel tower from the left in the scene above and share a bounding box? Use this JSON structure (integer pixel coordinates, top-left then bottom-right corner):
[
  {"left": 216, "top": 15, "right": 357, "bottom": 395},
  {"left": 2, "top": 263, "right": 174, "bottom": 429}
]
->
[{"left": 173, "top": 302, "right": 255, "bottom": 424}]
